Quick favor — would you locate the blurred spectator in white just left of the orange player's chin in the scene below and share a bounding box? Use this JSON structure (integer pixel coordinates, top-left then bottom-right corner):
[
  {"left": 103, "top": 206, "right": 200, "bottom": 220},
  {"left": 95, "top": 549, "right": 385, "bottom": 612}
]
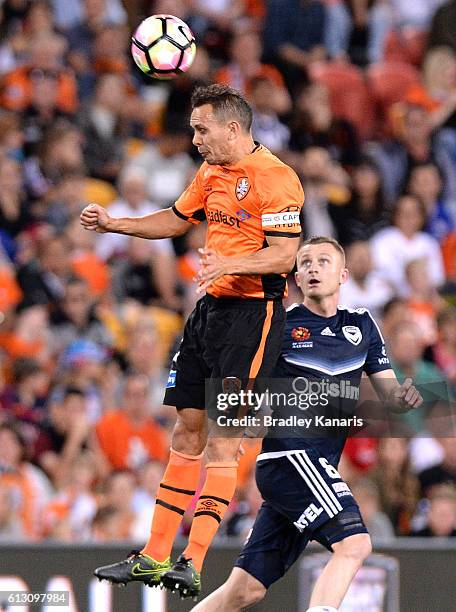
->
[{"left": 127, "top": 124, "right": 195, "bottom": 208}]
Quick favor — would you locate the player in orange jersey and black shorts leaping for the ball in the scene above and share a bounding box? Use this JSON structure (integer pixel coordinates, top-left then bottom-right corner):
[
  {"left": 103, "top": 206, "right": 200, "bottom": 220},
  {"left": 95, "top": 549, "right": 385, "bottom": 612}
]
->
[{"left": 81, "top": 85, "right": 304, "bottom": 596}]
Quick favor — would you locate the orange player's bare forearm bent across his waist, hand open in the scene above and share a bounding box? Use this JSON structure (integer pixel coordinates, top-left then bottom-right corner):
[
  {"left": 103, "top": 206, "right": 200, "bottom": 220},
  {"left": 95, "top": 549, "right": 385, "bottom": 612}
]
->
[{"left": 195, "top": 234, "right": 299, "bottom": 293}]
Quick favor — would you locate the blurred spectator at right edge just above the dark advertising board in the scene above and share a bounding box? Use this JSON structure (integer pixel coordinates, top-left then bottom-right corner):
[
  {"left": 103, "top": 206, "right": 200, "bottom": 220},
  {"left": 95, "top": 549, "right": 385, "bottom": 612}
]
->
[{"left": 410, "top": 487, "right": 456, "bottom": 538}]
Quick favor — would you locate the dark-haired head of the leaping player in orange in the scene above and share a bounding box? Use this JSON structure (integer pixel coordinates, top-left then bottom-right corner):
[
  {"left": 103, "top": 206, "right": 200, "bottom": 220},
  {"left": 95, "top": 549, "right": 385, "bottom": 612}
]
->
[{"left": 190, "top": 85, "right": 252, "bottom": 165}]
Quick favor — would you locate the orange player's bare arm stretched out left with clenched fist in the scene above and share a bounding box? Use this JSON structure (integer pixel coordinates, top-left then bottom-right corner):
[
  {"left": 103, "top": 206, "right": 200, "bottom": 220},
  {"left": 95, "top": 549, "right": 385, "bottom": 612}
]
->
[{"left": 80, "top": 204, "right": 191, "bottom": 239}]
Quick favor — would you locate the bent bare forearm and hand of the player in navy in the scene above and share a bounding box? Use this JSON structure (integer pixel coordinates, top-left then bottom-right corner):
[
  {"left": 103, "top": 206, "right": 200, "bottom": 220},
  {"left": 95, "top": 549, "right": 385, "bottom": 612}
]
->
[{"left": 369, "top": 369, "right": 423, "bottom": 413}]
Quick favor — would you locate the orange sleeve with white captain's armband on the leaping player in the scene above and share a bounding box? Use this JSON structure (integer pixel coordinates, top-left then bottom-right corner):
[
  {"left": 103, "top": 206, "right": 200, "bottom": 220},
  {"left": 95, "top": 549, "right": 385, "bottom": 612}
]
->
[{"left": 257, "top": 166, "right": 304, "bottom": 238}]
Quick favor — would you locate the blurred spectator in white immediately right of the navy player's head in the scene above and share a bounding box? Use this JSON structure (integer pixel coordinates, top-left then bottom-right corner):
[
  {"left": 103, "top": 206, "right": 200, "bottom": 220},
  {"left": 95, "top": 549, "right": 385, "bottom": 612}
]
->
[{"left": 340, "top": 241, "right": 393, "bottom": 319}]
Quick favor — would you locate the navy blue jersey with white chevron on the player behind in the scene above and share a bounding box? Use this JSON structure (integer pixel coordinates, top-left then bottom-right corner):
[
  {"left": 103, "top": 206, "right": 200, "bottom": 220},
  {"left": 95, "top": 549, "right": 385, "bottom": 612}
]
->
[{"left": 262, "top": 304, "right": 391, "bottom": 466}]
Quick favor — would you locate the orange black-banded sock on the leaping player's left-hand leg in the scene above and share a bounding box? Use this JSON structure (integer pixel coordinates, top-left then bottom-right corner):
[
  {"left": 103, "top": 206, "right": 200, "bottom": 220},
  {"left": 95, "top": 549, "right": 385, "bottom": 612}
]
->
[{"left": 141, "top": 448, "right": 203, "bottom": 561}]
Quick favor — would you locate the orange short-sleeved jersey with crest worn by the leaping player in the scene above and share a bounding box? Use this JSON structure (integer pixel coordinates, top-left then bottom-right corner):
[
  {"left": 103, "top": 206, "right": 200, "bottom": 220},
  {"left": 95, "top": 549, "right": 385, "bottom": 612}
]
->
[{"left": 173, "top": 145, "right": 304, "bottom": 299}]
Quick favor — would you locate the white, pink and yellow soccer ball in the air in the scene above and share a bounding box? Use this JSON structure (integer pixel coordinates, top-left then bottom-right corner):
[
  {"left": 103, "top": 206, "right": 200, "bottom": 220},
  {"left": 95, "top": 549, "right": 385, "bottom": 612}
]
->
[{"left": 131, "top": 15, "right": 196, "bottom": 79}]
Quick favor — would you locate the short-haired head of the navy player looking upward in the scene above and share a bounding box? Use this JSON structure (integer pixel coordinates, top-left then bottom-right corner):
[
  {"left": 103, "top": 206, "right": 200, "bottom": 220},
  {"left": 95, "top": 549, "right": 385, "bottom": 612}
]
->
[{"left": 295, "top": 236, "right": 348, "bottom": 301}]
